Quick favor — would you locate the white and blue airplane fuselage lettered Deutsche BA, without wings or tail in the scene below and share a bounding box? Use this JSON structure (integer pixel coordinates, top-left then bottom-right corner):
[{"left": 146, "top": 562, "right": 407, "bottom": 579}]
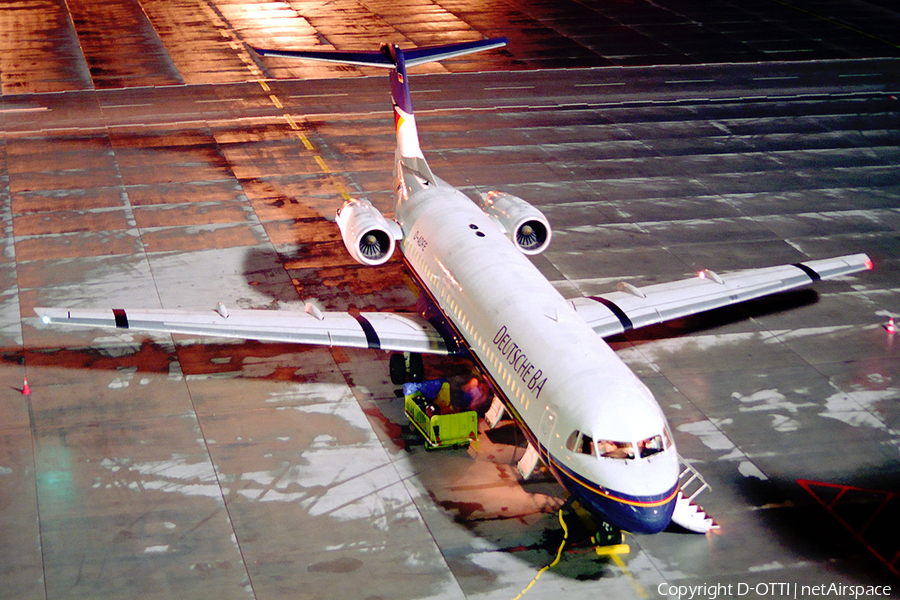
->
[{"left": 395, "top": 165, "right": 678, "bottom": 533}]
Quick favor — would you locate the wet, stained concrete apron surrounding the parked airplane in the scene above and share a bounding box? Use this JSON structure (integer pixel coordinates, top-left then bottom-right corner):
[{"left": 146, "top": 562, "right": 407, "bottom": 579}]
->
[{"left": 0, "top": 0, "right": 900, "bottom": 600}]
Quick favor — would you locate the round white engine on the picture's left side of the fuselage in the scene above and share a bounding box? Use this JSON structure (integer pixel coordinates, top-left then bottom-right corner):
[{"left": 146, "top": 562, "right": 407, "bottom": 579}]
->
[{"left": 337, "top": 199, "right": 403, "bottom": 266}]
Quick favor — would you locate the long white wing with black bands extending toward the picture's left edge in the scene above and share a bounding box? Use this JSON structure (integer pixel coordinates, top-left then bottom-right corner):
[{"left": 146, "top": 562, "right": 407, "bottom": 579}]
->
[{"left": 34, "top": 304, "right": 449, "bottom": 354}]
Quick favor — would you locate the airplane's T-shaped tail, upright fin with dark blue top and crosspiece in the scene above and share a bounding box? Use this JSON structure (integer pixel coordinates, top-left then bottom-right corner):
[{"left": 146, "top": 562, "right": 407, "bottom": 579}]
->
[{"left": 254, "top": 38, "right": 507, "bottom": 182}]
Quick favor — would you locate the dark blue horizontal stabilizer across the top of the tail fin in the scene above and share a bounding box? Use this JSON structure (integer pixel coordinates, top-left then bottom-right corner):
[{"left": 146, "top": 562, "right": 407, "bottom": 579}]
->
[{"left": 253, "top": 38, "right": 507, "bottom": 69}]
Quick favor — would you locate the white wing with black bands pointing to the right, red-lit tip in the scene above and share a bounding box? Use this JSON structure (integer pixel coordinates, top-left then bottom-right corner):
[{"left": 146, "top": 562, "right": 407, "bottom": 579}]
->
[{"left": 572, "top": 254, "right": 872, "bottom": 337}]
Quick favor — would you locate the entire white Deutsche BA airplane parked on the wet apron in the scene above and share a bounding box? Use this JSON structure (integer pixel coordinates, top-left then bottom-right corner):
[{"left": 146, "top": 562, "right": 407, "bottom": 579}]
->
[{"left": 35, "top": 39, "right": 872, "bottom": 533}]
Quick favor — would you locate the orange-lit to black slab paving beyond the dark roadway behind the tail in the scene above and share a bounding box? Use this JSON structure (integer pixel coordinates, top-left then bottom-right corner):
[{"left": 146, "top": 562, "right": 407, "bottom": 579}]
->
[{"left": 0, "top": 0, "right": 900, "bottom": 94}]
